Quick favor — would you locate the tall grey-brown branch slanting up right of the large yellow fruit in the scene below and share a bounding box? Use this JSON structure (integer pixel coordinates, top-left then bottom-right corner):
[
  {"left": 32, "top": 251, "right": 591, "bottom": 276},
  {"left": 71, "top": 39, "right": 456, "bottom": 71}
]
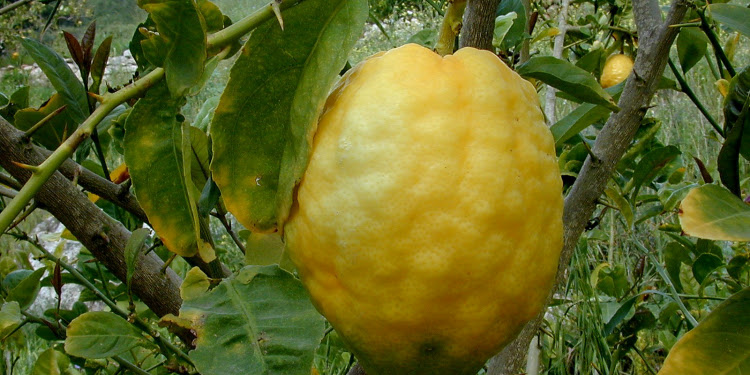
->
[{"left": 487, "top": 0, "right": 687, "bottom": 375}]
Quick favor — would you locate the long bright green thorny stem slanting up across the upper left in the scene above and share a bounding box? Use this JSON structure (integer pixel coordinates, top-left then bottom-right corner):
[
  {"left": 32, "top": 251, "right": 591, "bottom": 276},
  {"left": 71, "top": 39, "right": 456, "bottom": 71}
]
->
[{"left": 0, "top": 0, "right": 306, "bottom": 233}]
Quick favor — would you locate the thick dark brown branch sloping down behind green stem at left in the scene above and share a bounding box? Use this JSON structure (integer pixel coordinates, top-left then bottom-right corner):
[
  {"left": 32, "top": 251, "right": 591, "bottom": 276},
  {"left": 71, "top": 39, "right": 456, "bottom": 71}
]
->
[{"left": 0, "top": 118, "right": 182, "bottom": 316}]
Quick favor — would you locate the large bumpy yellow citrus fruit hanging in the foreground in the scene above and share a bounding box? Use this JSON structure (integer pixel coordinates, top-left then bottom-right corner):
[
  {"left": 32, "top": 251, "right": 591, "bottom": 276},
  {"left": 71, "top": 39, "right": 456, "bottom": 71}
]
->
[{"left": 285, "top": 44, "right": 563, "bottom": 375}]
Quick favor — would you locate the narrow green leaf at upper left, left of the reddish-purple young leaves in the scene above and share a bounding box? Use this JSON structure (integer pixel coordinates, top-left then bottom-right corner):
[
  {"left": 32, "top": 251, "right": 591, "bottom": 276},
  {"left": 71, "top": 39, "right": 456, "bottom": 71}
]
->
[{"left": 21, "top": 38, "right": 89, "bottom": 127}]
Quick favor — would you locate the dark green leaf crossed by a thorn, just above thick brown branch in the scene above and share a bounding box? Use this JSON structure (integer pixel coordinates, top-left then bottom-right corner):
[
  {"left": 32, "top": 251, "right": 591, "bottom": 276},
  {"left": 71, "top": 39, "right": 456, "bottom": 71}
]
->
[{"left": 15, "top": 94, "right": 78, "bottom": 150}]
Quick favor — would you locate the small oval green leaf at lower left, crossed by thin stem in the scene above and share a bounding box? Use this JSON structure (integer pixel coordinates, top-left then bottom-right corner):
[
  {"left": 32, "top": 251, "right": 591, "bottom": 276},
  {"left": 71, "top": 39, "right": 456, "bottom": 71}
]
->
[{"left": 65, "top": 311, "right": 149, "bottom": 359}]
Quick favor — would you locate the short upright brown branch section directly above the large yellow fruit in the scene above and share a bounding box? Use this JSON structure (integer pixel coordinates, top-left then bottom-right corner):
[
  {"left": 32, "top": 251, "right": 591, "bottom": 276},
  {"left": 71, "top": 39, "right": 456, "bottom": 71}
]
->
[{"left": 460, "top": 0, "right": 500, "bottom": 51}]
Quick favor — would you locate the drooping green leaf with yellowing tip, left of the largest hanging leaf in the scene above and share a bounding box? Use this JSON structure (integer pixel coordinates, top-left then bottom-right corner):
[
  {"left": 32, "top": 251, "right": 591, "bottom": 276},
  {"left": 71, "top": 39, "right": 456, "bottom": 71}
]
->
[{"left": 124, "top": 83, "right": 198, "bottom": 256}]
